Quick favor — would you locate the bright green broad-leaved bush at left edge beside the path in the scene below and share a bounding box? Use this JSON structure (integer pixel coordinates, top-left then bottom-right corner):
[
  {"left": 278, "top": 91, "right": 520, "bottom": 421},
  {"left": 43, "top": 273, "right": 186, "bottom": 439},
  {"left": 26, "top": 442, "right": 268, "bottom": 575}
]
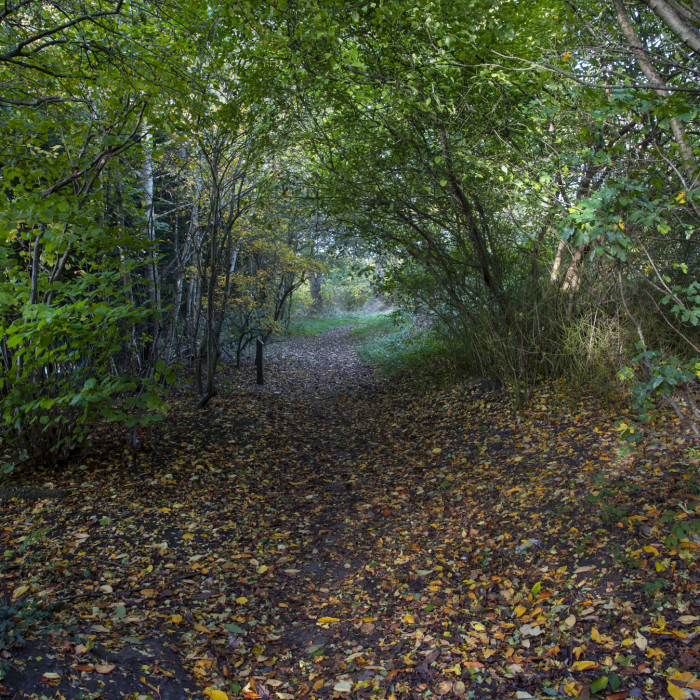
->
[{"left": 0, "top": 175, "right": 168, "bottom": 463}]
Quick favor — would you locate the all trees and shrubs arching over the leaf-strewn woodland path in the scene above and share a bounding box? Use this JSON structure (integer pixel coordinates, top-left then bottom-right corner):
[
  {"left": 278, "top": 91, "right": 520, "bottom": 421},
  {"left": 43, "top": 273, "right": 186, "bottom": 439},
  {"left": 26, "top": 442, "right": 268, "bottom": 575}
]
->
[{"left": 0, "top": 0, "right": 700, "bottom": 459}]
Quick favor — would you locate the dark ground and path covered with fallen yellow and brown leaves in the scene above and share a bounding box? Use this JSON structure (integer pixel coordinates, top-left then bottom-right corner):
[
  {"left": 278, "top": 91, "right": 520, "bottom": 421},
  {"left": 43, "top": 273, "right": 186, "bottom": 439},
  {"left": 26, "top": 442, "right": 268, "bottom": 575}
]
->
[{"left": 0, "top": 329, "right": 700, "bottom": 700}]
